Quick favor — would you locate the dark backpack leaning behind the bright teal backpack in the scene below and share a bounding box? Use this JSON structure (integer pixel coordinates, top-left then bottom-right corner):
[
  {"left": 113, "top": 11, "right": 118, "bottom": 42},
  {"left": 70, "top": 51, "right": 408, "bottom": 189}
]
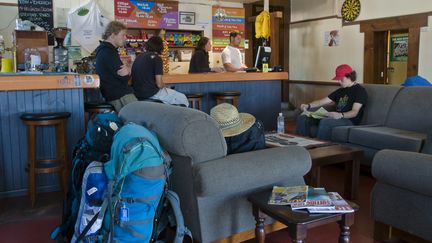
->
[{"left": 51, "top": 112, "right": 123, "bottom": 242}]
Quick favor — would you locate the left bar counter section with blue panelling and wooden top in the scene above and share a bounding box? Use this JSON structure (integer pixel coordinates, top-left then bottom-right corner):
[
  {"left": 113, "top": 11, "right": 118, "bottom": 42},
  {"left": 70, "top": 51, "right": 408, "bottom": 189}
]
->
[{"left": 0, "top": 73, "right": 99, "bottom": 197}]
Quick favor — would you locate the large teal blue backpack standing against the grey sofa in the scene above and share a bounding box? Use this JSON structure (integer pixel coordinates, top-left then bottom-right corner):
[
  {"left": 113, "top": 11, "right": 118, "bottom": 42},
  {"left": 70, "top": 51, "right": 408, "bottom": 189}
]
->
[{"left": 72, "top": 123, "right": 190, "bottom": 242}]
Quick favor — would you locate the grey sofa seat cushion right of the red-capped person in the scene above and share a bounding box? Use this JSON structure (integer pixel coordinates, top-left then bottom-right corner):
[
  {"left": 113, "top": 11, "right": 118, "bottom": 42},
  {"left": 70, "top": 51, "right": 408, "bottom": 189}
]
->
[{"left": 348, "top": 126, "right": 426, "bottom": 152}]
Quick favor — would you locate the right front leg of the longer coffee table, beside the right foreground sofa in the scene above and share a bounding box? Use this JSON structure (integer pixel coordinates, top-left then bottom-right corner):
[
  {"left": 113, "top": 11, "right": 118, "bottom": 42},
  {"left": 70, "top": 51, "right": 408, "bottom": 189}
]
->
[{"left": 344, "top": 155, "right": 360, "bottom": 200}]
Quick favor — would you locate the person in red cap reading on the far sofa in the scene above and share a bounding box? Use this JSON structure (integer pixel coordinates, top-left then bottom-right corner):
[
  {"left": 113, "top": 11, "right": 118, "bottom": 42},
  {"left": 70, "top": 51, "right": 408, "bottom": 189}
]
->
[{"left": 297, "top": 64, "right": 367, "bottom": 140}]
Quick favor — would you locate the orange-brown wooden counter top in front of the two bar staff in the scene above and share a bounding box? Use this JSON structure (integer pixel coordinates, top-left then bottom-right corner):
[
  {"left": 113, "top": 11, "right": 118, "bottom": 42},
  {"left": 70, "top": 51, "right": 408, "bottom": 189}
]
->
[{"left": 163, "top": 72, "right": 288, "bottom": 84}]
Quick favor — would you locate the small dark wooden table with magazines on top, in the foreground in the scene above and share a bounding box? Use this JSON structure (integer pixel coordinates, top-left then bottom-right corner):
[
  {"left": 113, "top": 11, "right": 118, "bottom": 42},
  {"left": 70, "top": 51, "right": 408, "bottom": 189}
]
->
[{"left": 248, "top": 189, "right": 359, "bottom": 243}]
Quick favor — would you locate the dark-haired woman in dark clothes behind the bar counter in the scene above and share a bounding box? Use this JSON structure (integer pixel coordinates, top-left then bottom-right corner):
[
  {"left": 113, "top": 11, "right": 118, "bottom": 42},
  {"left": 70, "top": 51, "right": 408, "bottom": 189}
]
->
[{"left": 189, "top": 36, "right": 224, "bottom": 73}]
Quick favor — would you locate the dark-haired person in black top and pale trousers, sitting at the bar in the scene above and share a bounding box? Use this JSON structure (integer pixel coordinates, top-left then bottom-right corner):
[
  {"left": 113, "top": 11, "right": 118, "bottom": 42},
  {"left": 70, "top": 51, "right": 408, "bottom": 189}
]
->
[{"left": 132, "top": 36, "right": 189, "bottom": 107}]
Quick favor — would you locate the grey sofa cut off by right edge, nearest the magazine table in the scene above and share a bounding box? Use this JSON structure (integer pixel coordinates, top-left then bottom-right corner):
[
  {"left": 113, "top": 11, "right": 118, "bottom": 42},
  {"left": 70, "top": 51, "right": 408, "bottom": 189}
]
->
[{"left": 371, "top": 149, "right": 432, "bottom": 242}]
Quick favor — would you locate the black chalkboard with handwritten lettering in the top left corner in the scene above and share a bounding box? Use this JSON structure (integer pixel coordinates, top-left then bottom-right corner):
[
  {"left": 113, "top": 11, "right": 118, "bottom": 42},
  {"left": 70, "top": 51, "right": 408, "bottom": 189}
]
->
[{"left": 18, "top": 0, "right": 54, "bottom": 45}]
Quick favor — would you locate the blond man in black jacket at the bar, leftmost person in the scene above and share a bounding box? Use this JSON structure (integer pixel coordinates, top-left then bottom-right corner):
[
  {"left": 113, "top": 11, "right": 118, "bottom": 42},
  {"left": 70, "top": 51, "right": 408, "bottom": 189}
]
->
[{"left": 96, "top": 21, "right": 137, "bottom": 112}]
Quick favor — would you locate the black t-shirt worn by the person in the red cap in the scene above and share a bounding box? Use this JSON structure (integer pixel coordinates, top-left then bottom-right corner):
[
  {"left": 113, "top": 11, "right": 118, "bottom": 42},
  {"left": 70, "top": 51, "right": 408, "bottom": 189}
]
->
[{"left": 328, "top": 84, "right": 367, "bottom": 125}]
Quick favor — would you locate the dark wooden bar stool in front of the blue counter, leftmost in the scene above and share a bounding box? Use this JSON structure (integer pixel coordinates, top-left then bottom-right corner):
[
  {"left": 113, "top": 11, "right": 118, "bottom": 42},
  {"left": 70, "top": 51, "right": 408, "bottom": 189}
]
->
[{"left": 20, "top": 112, "right": 71, "bottom": 207}]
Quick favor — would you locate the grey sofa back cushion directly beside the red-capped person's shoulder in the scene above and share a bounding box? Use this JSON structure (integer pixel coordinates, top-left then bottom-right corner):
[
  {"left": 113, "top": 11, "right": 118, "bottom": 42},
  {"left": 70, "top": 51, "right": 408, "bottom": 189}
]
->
[{"left": 360, "top": 84, "right": 402, "bottom": 125}]
